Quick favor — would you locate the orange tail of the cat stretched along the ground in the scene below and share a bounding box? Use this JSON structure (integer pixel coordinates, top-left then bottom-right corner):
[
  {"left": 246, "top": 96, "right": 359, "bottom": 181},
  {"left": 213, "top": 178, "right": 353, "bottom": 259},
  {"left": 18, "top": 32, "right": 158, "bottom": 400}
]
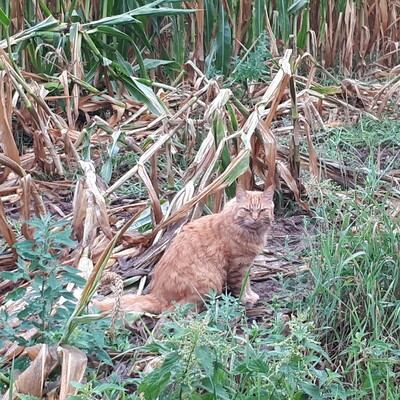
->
[{"left": 93, "top": 294, "right": 168, "bottom": 314}]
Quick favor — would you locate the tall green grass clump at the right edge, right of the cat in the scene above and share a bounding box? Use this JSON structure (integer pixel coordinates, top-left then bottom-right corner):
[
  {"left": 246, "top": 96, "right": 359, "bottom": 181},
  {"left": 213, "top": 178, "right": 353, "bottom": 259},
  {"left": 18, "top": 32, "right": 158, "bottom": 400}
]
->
[{"left": 308, "top": 179, "right": 400, "bottom": 399}]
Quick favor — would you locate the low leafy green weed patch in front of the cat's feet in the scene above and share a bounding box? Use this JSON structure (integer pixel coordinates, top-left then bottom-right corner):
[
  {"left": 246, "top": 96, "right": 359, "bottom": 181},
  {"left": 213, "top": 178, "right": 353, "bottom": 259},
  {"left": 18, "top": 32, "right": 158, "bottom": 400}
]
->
[{"left": 133, "top": 295, "right": 346, "bottom": 400}]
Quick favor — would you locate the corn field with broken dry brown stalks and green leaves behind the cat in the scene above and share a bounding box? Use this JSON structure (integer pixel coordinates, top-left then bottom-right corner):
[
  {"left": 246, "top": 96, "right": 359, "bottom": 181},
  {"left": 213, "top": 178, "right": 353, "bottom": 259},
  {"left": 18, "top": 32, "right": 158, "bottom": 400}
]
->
[{"left": 0, "top": 0, "right": 400, "bottom": 398}]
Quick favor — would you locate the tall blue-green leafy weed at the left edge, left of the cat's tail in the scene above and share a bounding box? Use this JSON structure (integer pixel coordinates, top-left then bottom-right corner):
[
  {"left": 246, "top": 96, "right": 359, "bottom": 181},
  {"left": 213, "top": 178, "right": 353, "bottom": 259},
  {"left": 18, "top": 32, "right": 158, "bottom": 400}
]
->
[{"left": 0, "top": 215, "right": 84, "bottom": 342}]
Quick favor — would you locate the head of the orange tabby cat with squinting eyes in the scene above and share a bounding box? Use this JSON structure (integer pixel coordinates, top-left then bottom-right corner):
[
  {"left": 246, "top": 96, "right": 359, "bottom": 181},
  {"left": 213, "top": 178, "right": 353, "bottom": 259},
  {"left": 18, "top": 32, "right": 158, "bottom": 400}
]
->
[{"left": 235, "top": 186, "right": 274, "bottom": 229}]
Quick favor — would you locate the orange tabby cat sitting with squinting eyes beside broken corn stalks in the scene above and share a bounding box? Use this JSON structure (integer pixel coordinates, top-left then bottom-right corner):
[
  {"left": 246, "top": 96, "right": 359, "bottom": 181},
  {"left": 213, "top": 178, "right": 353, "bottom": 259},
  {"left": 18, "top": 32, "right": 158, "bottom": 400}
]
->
[{"left": 94, "top": 186, "right": 274, "bottom": 314}]
